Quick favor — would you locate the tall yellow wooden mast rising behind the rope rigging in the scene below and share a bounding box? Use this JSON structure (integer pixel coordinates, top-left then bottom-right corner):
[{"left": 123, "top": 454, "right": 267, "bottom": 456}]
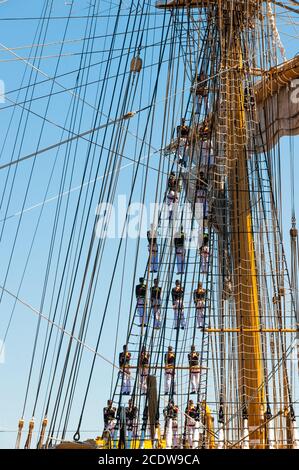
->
[{"left": 225, "top": 44, "right": 265, "bottom": 447}]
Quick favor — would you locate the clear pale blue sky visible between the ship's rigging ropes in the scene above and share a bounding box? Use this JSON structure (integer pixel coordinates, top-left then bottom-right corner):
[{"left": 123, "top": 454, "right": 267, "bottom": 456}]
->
[{"left": 0, "top": 0, "right": 299, "bottom": 448}]
